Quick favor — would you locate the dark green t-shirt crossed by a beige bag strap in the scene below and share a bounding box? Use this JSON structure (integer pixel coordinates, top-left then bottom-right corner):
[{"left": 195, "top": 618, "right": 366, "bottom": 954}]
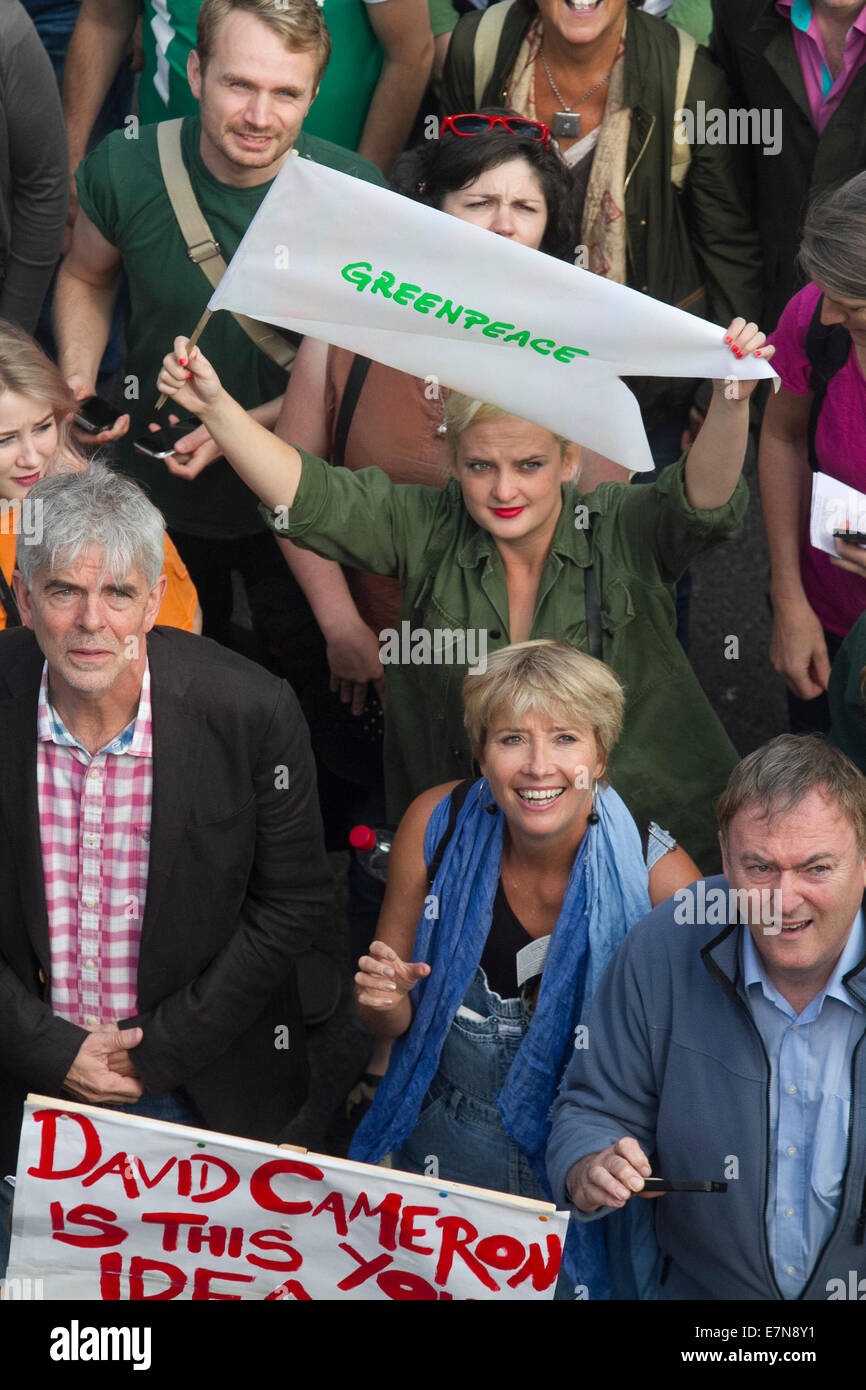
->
[{"left": 76, "top": 118, "right": 385, "bottom": 539}]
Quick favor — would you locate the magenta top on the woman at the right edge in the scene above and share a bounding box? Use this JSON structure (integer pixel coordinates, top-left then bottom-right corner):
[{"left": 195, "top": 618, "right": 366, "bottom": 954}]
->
[{"left": 769, "top": 285, "right": 866, "bottom": 637}]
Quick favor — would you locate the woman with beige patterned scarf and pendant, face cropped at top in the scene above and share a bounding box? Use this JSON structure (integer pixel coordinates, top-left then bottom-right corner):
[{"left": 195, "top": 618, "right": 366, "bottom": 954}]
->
[{"left": 442, "top": 0, "right": 763, "bottom": 466}]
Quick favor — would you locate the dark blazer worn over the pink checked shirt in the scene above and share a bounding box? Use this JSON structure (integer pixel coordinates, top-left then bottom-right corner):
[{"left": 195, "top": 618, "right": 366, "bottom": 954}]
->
[{"left": 0, "top": 627, "right": 331, "bottom": 1176}]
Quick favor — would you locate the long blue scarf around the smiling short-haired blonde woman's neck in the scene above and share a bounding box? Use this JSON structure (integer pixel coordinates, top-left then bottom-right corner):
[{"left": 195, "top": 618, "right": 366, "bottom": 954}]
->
[{"left": 350, "top": 787, "right": 651, "bottom": 1297}]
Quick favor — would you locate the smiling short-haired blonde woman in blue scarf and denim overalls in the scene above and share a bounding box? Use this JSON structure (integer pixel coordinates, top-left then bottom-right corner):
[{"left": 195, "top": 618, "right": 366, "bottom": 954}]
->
[{"left": 352, "top": 641, "right": 699, "bottom": 1298}]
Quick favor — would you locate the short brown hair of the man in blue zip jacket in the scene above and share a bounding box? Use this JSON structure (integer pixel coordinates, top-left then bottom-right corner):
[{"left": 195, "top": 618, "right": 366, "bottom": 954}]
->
[{"left": 716, "top": 734, "right": 866, "bottom": 853}]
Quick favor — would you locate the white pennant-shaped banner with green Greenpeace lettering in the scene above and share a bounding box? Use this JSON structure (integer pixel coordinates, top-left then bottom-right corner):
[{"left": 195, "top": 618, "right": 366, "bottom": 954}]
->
[{"left": 204, "top": 158, "right": 776, "bottom": 471}]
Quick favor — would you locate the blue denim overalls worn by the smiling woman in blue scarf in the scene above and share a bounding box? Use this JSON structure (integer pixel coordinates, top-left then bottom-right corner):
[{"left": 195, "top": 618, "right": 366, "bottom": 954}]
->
[{"left": 393, "top": 966, "right": 549, "bottom": 1201}]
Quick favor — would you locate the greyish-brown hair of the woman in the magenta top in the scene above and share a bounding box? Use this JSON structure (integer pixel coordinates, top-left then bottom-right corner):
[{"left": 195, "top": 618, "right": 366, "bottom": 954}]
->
[{"left": 799, "top": 172, "right": 866, "bottom": 299}]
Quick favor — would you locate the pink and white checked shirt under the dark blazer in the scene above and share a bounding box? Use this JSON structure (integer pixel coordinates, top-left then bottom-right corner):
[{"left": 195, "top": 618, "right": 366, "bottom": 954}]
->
[{"left": 36, "top": 662, "right": 153, "bottom": 1027}]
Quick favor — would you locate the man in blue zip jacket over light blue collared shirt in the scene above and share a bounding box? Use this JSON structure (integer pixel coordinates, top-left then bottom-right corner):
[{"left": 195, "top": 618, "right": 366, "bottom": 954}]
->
[{"left": 548, "top": 734, "right": 866, "bottom": 1300}]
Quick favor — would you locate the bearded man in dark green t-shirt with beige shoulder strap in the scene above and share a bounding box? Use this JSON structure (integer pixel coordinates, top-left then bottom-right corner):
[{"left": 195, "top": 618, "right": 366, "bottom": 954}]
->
[{"left": 54, "top": 0, "right": 384, "bottom": 651}]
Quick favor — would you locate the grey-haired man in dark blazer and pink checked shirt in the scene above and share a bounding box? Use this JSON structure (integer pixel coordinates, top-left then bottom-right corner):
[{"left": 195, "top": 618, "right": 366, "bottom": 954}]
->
[{"left": 0, "top": 466, "right": 328, "bottom": 1264}]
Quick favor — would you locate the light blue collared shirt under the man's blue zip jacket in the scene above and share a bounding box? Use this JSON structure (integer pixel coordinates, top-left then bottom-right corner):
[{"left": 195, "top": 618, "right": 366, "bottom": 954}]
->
[{"left": 742, "top": 910, "right": 866, "bottom": 1298}]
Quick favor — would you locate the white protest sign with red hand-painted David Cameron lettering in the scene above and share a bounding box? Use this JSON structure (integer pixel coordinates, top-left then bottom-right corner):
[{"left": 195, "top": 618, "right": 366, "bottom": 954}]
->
[{"left": 8, "top": 1095, "right": 569, "bottom": 1301}]
